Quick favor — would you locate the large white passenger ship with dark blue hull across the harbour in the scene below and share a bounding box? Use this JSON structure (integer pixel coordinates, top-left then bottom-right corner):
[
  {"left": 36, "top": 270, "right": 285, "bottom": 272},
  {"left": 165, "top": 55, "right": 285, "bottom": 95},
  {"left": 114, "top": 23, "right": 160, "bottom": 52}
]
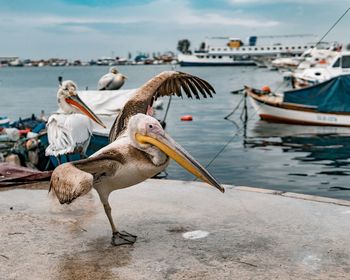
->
[{"left": 178, "top": 35, "right": 315, "bottom": 66}]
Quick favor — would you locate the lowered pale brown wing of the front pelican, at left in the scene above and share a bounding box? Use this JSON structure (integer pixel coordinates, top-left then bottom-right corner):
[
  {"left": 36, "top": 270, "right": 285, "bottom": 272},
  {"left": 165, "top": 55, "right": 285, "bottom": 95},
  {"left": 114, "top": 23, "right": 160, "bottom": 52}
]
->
[{"left": 49, "top": 152, "right": 125, "bottom": 204}]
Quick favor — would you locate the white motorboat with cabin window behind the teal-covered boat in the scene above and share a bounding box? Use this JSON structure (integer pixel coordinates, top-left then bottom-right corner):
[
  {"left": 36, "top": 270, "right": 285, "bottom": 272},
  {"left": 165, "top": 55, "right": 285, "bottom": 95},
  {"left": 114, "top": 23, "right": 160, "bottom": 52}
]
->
[{"left": 292, "top": 51, "right": 350, "bottom": 88}]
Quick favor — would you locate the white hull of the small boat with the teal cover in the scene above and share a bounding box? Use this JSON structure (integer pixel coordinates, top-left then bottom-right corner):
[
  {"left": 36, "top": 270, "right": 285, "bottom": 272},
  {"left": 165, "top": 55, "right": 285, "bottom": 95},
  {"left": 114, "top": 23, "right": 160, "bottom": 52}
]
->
[{"left": 248, "top": 93, "right": 350, "bottom": 127}]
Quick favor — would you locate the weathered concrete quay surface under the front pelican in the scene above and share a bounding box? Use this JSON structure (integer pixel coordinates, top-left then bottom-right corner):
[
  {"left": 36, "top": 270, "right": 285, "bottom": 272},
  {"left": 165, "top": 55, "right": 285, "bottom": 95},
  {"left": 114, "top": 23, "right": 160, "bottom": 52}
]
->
[{"left": 0, "top": 180, "right": 350, "bottom": 279}]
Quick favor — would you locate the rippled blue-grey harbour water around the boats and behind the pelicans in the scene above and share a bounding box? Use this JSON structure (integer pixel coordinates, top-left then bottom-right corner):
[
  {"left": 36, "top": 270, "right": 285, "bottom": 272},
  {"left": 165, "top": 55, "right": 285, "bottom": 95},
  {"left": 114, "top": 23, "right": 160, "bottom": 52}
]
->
[{"left": 0, "top": 65, "right": 350, "bottom": 199}]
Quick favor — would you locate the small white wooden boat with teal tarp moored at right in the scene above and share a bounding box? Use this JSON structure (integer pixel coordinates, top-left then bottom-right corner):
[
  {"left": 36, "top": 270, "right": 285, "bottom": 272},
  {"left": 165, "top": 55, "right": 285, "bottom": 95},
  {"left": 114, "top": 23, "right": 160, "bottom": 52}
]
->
[{"left": 245, "top": 75, "right": 350, "bottom": 127}]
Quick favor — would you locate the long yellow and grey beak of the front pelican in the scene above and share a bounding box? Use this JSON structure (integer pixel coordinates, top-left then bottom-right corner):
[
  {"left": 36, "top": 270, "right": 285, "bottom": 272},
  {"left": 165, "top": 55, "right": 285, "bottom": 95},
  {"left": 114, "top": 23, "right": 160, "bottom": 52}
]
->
[{"left": 135, "top": 133, "right": 225, "bottom": 192}]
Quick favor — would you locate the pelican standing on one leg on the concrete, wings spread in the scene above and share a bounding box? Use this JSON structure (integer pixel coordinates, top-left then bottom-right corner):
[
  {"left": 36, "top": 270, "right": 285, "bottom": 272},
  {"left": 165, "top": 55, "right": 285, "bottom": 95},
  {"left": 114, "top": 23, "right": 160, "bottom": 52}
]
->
[{"left": 49, "top": 71, "right": 224, "bottom": 246}]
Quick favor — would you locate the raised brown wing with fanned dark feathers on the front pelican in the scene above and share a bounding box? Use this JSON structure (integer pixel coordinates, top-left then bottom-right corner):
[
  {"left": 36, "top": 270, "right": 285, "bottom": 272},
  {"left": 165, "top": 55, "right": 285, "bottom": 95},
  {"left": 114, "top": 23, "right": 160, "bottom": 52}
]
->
[{"left": 109, "top": 71, "right": 215, "bottom": 142}]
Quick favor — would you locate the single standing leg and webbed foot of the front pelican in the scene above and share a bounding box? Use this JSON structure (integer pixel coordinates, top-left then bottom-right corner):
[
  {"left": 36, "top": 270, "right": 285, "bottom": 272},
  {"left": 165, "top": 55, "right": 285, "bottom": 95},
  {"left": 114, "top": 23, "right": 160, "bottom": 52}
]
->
[{"left": 96, "top": 189, "right": 137, "bottom": 246}]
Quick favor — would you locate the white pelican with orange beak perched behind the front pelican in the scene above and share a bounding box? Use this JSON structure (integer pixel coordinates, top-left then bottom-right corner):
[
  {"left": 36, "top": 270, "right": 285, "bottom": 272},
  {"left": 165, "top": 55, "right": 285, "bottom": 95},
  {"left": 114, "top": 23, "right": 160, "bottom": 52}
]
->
[{"left": 45, "top": 80, "right": 105, "bottom": 160}]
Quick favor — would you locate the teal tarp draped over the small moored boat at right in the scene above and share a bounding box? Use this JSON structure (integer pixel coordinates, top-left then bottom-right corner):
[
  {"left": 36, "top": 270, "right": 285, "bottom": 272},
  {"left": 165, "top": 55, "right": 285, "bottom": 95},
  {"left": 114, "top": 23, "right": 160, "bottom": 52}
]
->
[{"left": 283, "top": 75, "right": 350, "bottom": 113}]
